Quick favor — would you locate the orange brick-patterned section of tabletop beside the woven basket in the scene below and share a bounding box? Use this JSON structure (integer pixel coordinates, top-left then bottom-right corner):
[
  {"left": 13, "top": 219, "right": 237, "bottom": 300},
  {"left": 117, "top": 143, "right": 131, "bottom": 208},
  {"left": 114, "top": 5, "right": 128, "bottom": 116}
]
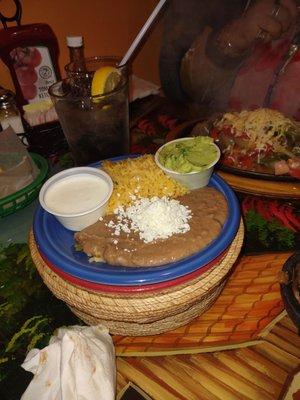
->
[{"left": 113, "top": 253, "right": 290, "bottom": 356}]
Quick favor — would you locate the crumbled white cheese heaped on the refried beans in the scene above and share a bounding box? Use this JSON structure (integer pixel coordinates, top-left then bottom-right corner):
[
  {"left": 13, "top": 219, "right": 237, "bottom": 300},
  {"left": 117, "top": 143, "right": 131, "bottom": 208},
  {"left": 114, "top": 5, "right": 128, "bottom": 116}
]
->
[{"left": 107, "top": 196, "right": 192, "bottom": 243}]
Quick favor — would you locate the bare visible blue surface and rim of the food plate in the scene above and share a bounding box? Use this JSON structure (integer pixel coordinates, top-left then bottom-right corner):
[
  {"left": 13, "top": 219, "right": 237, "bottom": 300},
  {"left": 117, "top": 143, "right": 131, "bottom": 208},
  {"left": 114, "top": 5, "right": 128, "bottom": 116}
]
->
[{"left": 33, "top": 157, "right": 240, "bottom": 286}]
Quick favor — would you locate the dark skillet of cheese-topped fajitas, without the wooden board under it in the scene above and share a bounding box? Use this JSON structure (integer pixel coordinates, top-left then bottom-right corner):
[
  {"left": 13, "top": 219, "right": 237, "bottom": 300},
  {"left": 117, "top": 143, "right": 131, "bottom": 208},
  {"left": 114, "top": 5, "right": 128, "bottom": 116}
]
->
[{"left": 191, "top": 108, "right": 300, "bottom": 181}]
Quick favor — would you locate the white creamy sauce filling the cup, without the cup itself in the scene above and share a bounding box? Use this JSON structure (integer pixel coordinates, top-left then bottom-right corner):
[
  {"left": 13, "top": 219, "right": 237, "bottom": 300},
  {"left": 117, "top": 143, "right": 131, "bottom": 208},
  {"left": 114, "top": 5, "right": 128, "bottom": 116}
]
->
[{"left": 44, "top": 174, "right": 109, "bottom": 214}]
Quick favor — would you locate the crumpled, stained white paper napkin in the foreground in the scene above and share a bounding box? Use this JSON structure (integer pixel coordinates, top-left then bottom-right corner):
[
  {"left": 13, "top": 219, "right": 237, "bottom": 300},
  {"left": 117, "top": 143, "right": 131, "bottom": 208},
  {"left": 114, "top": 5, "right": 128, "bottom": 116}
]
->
[{"left": 21, "top": 325, "right": 116, "bottom": 400}]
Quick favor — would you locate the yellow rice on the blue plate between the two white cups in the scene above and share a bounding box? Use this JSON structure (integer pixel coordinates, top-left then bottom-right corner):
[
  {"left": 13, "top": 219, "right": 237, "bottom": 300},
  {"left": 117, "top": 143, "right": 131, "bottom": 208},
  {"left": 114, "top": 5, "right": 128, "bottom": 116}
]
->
[{"left": 102, "top": 154, "right": 188, "bottom": 214}]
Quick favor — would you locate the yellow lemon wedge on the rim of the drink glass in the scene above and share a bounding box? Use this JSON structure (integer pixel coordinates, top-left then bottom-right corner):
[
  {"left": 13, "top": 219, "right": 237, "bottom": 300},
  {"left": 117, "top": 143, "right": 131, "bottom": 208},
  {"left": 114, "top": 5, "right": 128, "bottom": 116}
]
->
[{"left": 91, "top": 66, "right": 121, "bottom": 96}]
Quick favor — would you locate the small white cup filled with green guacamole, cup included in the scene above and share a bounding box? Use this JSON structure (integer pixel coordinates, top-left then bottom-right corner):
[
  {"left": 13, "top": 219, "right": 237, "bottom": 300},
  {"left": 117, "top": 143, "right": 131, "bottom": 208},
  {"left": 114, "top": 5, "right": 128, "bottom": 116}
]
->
[{"left": 155, "top": 136, "right": 221, "bottom": 189}]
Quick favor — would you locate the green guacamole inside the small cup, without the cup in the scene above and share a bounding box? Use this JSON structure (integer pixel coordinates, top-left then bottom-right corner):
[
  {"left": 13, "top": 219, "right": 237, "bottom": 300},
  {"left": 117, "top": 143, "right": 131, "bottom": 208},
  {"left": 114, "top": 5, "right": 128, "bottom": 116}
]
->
[{"left": 158, "top": 136, "right": 218, "bottom": 173}]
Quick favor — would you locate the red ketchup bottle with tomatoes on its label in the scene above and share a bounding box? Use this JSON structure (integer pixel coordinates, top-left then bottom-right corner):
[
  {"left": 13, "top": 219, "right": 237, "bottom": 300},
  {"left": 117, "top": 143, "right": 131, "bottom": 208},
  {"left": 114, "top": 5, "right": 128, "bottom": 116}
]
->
[{"left": 0, "top": 1, "right": 60, "bottom": 106}]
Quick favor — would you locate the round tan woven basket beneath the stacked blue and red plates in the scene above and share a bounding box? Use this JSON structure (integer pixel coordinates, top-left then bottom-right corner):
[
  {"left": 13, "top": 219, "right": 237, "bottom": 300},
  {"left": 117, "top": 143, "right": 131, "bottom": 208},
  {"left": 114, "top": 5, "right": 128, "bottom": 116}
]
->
[{"left": 29, "top": 222, "right": 244, "bottom": 336}]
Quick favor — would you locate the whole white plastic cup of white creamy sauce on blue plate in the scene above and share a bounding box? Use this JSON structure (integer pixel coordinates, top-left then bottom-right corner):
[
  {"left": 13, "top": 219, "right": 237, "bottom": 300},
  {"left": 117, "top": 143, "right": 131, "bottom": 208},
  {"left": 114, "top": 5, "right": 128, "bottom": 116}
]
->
[{"left": 39, "top": 167, "right": 113, "bottom": 231}]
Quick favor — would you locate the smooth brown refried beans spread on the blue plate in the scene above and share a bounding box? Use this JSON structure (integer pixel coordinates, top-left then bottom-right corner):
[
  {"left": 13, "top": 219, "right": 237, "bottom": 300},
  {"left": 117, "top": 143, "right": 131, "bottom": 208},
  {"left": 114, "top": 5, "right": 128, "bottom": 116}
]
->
[{"left": 75, "top": 187, "right": 228, "bottom": 267}]
